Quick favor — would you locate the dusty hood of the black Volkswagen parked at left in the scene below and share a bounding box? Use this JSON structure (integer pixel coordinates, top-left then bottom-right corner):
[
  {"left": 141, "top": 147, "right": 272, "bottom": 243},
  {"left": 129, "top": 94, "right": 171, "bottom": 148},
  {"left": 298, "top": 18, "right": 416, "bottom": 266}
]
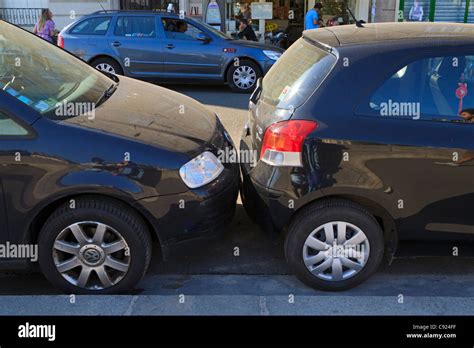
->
[{"left": 64, "top": 77, "right": 224, "bottom": 156}]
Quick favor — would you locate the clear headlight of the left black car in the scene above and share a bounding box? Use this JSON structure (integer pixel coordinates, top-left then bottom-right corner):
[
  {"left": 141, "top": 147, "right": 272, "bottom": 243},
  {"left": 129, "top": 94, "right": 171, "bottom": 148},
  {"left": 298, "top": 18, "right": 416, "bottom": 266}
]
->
[{"left": 179, "top": 151, "right": 224, "bottom": 188}]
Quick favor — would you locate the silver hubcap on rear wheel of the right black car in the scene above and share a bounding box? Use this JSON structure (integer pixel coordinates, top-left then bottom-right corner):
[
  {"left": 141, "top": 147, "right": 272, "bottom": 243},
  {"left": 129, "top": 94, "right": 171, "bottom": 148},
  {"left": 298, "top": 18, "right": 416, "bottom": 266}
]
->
[{"left": 303, "top": 221, "right": 370, "bottom": 281}]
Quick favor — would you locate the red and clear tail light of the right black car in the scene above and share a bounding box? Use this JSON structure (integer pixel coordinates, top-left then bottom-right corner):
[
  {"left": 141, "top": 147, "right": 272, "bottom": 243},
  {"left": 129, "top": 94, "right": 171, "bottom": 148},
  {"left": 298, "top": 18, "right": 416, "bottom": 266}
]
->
[{"left": 260, "top": 120, "right": 318, "bottom": 167}]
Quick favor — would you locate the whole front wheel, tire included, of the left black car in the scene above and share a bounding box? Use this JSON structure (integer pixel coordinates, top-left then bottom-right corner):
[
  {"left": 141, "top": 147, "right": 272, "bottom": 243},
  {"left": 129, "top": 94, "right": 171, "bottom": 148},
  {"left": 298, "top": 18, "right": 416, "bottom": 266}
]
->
[{"left": 38, "top": 198, "right": 151, "bottom": 294}]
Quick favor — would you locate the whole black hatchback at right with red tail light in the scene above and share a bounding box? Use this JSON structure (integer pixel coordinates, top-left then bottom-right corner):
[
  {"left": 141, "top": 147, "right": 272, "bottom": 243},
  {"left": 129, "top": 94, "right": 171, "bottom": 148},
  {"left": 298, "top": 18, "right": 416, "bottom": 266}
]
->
[{"left": 240, "top": 23, "right": 474, "bottom": 290}]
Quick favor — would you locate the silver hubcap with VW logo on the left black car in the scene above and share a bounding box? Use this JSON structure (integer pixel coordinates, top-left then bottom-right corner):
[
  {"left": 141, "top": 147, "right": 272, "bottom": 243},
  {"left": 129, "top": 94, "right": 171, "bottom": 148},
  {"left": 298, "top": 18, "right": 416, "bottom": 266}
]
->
[{"left": 53, "top": 221, "right": 131, "bottom": 290}]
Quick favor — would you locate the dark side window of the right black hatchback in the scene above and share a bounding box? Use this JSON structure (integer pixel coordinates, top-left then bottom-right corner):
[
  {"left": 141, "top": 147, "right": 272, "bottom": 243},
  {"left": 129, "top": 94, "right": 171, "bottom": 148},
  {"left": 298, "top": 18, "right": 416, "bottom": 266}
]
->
[{"left": 362, "top": 55, "right": 474, "bottom": 122}]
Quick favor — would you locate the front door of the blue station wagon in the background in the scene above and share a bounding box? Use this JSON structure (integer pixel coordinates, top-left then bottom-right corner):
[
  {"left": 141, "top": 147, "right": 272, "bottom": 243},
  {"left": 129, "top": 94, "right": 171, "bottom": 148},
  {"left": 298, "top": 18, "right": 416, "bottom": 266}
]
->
[{"left": 160, "top": 17, "right": 224, "bottom": 80}]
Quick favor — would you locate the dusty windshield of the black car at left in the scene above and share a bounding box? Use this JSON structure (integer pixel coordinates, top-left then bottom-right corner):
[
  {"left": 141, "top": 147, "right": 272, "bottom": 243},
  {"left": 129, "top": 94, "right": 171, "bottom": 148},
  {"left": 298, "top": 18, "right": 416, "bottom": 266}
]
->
[{"left": 0, "top": 21, "right": 115, "bottom": 117}]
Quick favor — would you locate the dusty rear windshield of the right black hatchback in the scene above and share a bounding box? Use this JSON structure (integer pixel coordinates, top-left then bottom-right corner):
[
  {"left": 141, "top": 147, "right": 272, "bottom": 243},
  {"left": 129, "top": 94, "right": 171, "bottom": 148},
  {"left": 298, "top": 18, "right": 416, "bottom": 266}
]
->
[{"left": 261, "top": 38, "right": 337, "bottom": 109}]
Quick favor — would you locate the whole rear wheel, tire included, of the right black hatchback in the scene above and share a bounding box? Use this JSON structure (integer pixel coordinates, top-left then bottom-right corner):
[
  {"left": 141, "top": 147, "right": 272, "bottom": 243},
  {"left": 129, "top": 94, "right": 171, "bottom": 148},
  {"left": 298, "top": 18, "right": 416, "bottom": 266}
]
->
[{"left": 285, "top": 200, "right": 384, "bottom": 291}]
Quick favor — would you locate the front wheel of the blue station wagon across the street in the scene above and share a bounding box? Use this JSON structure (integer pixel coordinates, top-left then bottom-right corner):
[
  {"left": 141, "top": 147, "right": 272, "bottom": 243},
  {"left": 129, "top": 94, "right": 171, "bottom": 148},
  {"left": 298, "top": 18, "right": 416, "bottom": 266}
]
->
[{"left": 227, "top": 59, "right": 262, "bottom": 93}]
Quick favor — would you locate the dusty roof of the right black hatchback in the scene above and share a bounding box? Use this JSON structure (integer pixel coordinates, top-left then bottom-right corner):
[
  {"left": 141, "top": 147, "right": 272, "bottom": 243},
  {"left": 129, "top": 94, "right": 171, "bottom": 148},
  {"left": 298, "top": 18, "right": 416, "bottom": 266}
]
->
[{"left": 303, "top": 22, "right": 474, "bottom": 47}]
